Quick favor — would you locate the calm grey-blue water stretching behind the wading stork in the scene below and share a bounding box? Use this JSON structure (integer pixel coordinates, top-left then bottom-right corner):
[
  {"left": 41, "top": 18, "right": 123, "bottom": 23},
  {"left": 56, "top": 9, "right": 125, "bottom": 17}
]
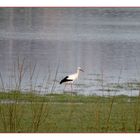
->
[{"left": 0, "top": 8, "right": 140, "bottom": 95}]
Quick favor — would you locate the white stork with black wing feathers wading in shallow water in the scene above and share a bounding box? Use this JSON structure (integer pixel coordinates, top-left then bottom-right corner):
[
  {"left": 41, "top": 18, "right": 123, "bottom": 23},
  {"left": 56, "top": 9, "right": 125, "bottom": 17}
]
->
[{"left": 60, "top": 67, "right": 84, "bottom": 91}]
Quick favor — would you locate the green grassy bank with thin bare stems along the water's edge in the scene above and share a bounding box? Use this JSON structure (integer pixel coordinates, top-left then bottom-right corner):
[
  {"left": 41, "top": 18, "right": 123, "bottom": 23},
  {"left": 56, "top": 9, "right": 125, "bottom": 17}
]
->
[{"left": 0, "top": 91, "right": 140, "bottom": 132}]
